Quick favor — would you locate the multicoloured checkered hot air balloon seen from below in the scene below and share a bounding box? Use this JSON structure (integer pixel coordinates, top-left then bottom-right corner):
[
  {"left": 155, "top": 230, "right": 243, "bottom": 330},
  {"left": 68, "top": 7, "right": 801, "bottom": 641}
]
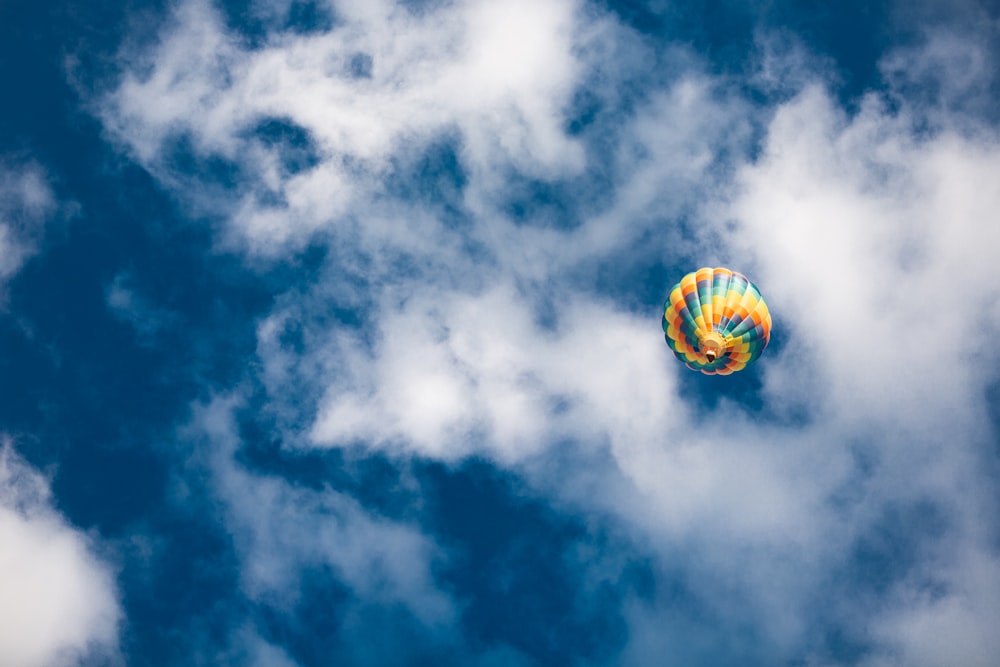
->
[{"left": 663, "top": 268, "right": 771, "bottom": 375}]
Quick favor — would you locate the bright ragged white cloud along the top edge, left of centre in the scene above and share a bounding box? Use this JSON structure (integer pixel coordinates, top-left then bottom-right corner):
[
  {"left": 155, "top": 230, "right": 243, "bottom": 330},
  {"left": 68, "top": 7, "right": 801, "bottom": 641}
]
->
[{"left": 102, "top": 0, "right": 583, "bottom": 253}]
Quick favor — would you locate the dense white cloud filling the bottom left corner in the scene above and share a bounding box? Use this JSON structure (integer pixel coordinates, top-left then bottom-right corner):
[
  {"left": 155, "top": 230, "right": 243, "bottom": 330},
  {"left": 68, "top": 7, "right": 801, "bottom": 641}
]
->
[{"left": 0, "top": 442, "right": 121, "bottom": 667}]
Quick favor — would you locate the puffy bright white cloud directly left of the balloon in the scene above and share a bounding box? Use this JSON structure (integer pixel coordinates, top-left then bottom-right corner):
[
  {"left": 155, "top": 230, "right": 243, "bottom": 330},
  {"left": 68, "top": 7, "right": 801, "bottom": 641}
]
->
[{"left": 312, "top": 287, "right": 675, "bottom": 462}]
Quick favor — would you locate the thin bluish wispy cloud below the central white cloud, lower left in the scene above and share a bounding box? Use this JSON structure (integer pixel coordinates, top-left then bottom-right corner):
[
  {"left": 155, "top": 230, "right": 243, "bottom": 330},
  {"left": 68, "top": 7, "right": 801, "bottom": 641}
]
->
[{"left": 190, "top": 399, "right": 453, "bottom": 627}]
